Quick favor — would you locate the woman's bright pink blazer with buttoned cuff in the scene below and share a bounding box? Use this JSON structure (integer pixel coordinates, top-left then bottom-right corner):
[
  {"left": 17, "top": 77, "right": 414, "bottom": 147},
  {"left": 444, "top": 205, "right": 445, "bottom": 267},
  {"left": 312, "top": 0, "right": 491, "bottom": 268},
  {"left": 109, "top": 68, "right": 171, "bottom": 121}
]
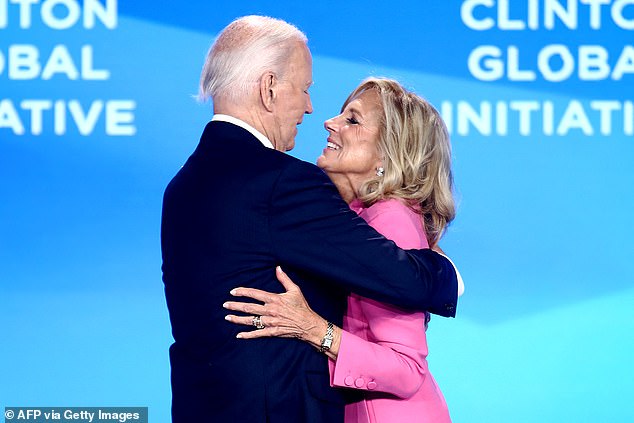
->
[{"left": 329, "top": 200, "right": 451, "bottom": 423}]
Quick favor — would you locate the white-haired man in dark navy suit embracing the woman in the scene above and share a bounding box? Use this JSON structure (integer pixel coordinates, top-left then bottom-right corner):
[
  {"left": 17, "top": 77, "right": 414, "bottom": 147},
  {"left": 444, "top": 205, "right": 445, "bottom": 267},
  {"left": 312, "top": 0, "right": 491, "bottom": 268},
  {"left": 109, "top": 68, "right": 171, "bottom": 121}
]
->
[{"left": 162, "top": 16, "right": 457, "bottom": 423}]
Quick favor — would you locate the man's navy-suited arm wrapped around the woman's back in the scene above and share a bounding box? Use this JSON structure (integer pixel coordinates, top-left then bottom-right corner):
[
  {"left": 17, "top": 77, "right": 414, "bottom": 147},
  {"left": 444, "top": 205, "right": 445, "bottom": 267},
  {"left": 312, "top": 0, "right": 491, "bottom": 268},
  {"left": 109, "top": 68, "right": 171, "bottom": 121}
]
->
[{"left": 269, "top": 162, "right": 458, "bottom": 317}]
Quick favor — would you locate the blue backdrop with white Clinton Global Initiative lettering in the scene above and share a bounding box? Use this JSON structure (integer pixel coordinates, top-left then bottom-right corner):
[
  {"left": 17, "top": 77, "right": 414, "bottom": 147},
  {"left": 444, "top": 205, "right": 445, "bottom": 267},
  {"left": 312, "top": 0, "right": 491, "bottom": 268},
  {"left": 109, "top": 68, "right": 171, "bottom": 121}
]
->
[{"left": 0, "top": 0, "right": 634, "bottom": 423}]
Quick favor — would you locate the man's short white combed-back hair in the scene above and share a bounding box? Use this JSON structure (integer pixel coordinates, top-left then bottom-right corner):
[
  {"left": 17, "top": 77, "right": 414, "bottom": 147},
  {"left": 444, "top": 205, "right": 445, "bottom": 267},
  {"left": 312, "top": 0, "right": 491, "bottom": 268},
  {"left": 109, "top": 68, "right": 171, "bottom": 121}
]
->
[{"left": 198, "top": 15, "right": 308, "bottom": 102}]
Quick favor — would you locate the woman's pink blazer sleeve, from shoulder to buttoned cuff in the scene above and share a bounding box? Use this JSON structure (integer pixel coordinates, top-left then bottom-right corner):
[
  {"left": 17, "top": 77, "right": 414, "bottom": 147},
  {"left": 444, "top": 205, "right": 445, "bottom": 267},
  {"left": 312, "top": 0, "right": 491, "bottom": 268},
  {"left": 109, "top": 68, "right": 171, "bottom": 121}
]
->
[{"left": 329, "top": 204, "right": 428, "bottom": 398}]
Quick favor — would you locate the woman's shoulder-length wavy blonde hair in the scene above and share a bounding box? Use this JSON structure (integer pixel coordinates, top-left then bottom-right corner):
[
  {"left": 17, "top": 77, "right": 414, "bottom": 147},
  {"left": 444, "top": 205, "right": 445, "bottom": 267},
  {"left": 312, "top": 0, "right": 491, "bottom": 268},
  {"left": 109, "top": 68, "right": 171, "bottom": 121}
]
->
[{"left": 342, "top": 78, "right": 456, "bottom": 247}]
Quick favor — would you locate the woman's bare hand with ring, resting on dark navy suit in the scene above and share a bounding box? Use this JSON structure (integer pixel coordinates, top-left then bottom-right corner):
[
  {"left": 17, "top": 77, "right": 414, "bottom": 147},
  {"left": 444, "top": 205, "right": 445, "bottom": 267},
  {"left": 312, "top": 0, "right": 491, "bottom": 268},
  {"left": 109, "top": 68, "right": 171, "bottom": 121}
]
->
[{"left": 223, "top": 266, "right": 328, "bottom": 347}]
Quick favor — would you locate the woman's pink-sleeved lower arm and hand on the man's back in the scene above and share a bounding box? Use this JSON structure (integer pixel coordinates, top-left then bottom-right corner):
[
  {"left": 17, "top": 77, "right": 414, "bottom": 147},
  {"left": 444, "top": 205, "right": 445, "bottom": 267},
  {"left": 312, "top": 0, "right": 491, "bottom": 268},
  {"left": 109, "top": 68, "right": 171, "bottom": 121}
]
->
[{"left": 224, "top": 267, "right": 427, "bottom": 398}]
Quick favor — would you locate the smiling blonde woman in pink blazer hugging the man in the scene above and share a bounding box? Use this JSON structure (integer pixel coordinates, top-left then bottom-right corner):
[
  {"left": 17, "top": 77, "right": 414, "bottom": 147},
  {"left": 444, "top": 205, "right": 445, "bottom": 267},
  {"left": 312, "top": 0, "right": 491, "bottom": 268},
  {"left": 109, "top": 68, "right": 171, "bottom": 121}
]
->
[{"left": 225, "top": 78, "right": 455, "bottom": 423}]
